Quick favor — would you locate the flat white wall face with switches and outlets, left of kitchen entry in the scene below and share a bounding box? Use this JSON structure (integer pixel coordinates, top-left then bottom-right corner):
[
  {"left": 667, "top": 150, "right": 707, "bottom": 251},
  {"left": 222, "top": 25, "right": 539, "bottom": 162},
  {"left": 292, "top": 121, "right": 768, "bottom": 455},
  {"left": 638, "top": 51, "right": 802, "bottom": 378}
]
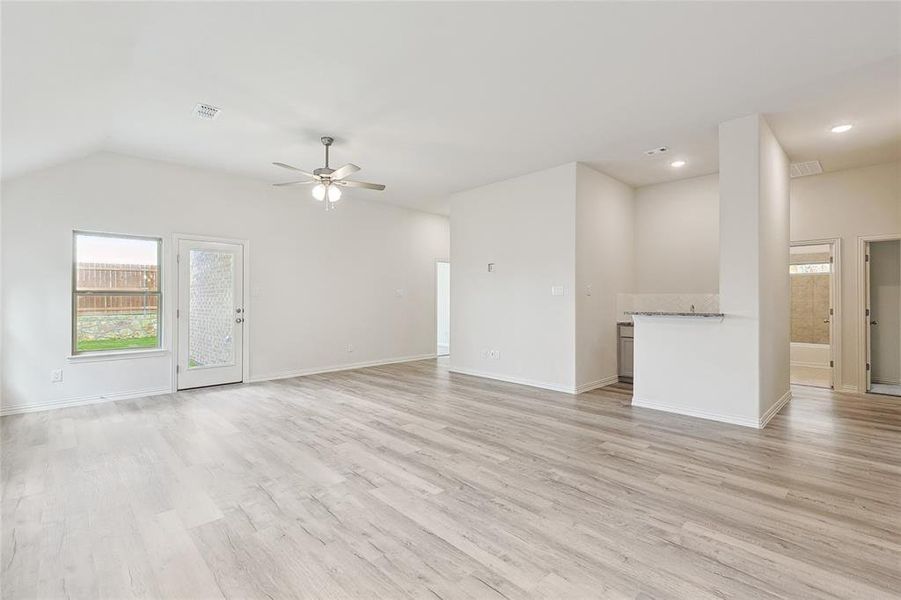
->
[{"left": 450, "top": 163, "right": 576, "bottom": 391}]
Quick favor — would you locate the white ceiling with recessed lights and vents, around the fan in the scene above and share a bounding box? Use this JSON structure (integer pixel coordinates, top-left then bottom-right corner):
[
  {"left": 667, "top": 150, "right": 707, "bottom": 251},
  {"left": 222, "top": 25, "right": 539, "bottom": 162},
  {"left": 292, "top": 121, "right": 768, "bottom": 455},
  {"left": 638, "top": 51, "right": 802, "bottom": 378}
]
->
[{"left": 2, "top": 2, "right": 901, "bottom": 212}]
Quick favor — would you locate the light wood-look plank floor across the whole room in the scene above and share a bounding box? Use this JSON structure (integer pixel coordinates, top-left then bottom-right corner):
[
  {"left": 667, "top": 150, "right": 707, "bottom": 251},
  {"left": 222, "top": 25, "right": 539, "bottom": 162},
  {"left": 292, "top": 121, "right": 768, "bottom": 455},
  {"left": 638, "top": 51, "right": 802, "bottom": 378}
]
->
[{"left": 0, "top": 361, "right": 901, "bottom": 600}]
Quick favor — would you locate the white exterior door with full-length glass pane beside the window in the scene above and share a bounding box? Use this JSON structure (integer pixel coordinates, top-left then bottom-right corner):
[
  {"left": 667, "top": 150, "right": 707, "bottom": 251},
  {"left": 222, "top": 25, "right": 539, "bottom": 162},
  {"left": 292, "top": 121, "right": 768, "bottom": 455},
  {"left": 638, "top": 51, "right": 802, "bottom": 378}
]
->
[{"left": 176, "top": 240, "right": 246, "bottom": 390}]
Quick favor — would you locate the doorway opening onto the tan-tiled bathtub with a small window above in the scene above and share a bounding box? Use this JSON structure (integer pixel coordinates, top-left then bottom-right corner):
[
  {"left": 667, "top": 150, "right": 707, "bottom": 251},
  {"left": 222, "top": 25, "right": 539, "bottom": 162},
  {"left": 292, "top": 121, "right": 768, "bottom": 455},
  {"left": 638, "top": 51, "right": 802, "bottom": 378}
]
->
[{"left": 789, "top": 240, "right": 838, "bottom": 388}]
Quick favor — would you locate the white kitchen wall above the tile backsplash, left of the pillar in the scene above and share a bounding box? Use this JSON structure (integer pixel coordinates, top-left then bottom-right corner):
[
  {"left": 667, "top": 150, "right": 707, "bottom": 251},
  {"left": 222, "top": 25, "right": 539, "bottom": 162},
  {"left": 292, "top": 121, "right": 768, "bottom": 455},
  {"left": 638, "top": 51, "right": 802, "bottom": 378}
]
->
[{"left": 635, "top": 174, "right": 720, "bottom": 294}]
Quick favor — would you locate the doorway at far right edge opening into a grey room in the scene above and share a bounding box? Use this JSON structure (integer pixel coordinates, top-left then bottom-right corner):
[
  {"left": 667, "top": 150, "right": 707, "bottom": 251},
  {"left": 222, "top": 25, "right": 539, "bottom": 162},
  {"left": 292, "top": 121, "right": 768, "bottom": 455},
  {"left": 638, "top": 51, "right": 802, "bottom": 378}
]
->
[{"left": 864, "top": 239, "right": 901, "bottom": 396}]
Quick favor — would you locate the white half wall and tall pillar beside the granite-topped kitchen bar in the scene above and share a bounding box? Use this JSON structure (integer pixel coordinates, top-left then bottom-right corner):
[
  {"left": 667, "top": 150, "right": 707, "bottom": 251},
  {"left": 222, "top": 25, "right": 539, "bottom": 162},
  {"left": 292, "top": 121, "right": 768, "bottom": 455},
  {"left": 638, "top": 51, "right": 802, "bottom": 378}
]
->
[{"left": 632, "top": 115, "right": 789, "bottom": 427}]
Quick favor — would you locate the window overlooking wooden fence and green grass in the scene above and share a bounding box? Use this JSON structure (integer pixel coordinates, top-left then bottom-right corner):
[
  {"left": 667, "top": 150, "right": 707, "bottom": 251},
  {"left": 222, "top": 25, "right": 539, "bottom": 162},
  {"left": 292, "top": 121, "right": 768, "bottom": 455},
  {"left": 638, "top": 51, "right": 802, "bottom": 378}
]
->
[{"left": 72, "top": 231, "right": 162, "bottom": 354}]
